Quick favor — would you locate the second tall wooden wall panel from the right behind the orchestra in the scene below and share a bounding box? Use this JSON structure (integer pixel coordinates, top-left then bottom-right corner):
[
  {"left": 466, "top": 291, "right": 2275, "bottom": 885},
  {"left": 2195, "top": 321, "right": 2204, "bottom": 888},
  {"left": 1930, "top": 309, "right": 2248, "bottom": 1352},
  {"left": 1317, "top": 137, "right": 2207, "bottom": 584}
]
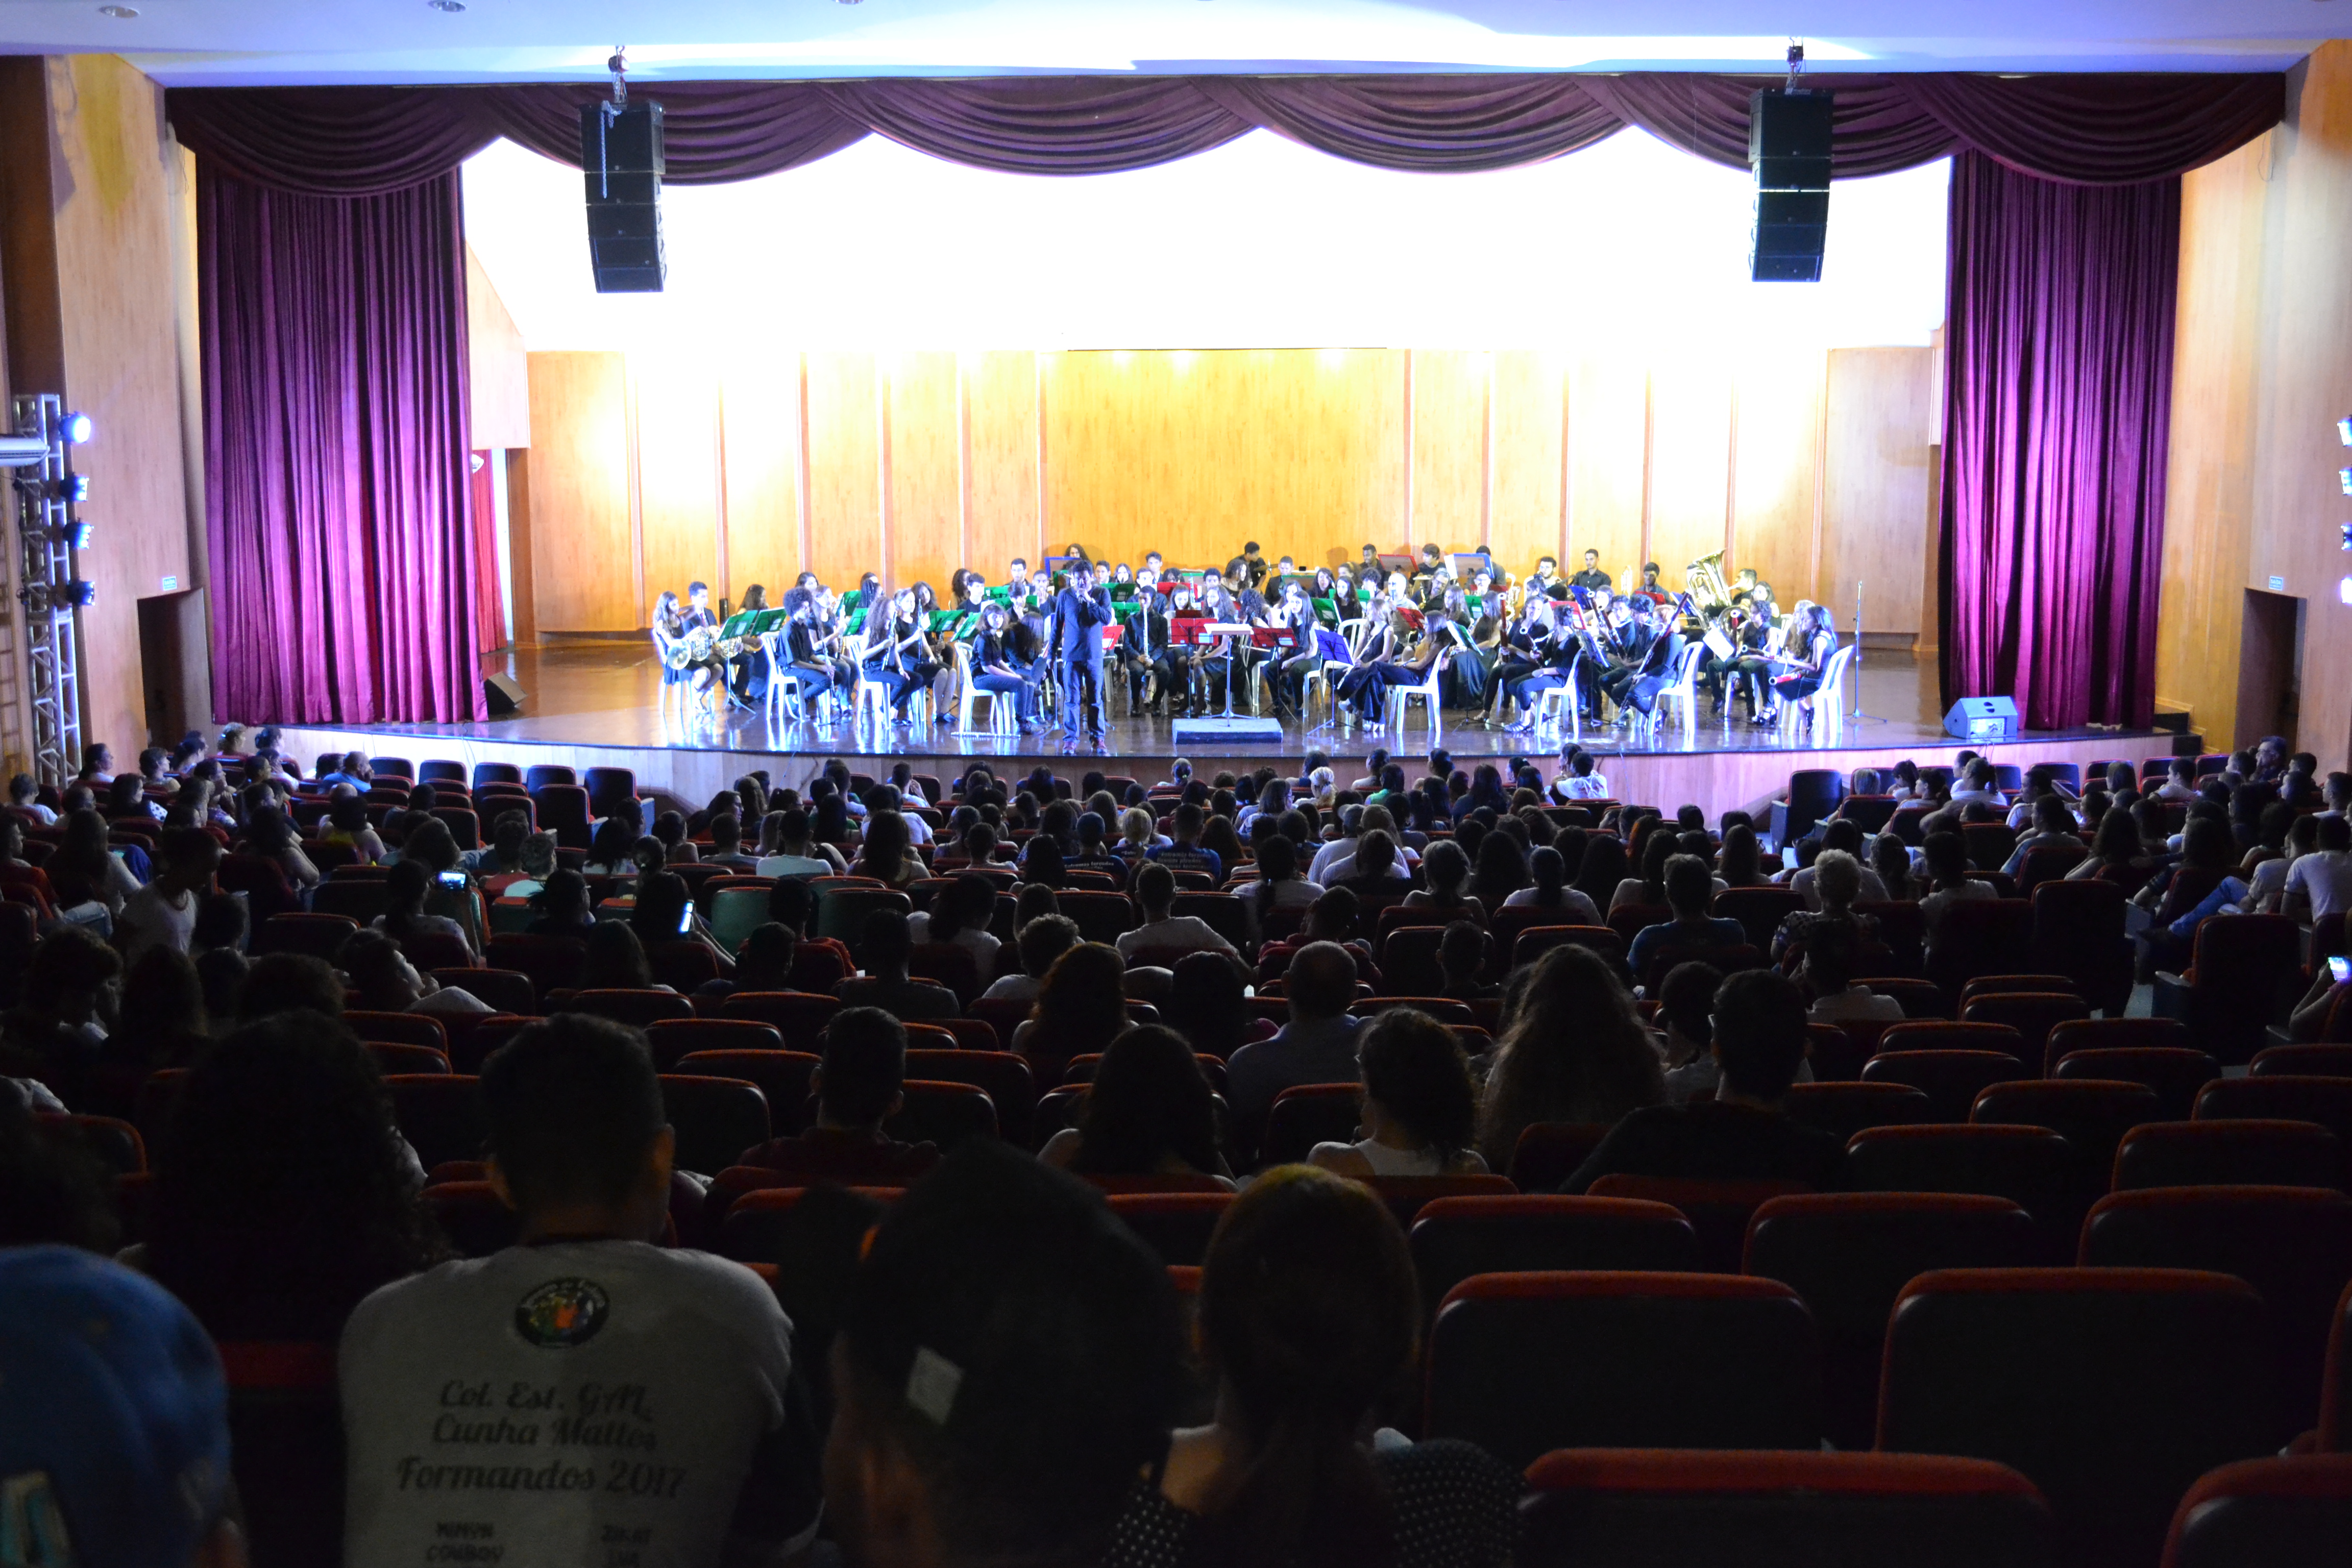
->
[{"left": 1724, "top": 357, "right": 1823, "bottom": 604}]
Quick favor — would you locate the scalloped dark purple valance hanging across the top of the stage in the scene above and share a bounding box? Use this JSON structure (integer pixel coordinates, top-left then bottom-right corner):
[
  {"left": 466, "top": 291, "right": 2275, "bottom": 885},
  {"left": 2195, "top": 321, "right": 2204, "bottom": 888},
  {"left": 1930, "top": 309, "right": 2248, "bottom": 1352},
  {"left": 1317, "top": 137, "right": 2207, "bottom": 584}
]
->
[{"left": 167, "top": 73, "right": 2286, "bottom": 195}]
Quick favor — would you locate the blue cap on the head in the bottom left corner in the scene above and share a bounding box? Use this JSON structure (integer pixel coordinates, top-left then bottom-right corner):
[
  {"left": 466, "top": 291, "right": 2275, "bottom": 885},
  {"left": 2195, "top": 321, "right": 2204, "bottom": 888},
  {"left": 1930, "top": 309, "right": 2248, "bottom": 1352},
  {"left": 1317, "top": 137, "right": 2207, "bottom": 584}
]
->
[{"left": 0, "top": 1246, "right": 228, "bottom": 1568}]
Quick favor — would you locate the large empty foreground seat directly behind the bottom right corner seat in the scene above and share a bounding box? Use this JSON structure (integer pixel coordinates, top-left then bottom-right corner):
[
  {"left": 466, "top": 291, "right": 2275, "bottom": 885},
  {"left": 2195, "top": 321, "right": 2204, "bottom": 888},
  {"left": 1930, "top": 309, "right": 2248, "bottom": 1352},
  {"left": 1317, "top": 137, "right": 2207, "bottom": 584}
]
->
[{"left": 1877, "top": 1269, "right": 2270, "bottom": 1568}]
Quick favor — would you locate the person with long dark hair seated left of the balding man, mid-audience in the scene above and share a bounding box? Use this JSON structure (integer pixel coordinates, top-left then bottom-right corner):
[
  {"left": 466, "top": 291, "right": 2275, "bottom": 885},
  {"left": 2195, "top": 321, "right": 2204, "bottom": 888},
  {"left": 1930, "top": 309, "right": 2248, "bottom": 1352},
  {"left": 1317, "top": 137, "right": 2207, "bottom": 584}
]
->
[{"left": 1037, "top": 1025, "right": 1233, "bottom": 1187}]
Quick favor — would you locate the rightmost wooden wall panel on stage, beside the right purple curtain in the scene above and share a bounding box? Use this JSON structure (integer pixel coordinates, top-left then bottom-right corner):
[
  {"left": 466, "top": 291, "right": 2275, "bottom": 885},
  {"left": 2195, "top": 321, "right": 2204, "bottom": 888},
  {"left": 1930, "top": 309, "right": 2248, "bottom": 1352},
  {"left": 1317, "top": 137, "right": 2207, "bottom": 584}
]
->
[{"left": 1814, "top": 348, "right": 1933, "bottom": 635}]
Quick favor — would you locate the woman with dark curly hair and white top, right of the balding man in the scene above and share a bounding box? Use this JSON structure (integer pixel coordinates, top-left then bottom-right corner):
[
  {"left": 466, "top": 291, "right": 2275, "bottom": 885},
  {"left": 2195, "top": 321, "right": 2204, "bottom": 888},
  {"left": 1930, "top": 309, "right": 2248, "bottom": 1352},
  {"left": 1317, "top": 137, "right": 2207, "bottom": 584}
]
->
[{"left": 1308, "top": 1006, "right": 1486, "bottom": 1175}]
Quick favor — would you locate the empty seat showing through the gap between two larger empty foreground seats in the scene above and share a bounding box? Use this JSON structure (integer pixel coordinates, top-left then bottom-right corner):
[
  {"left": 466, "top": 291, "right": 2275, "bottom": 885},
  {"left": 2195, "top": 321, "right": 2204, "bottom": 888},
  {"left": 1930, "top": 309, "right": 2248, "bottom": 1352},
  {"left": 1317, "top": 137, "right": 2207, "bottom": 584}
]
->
[{"left": 1745, "top": 1192, "right": 2037, "bottom": 1448}]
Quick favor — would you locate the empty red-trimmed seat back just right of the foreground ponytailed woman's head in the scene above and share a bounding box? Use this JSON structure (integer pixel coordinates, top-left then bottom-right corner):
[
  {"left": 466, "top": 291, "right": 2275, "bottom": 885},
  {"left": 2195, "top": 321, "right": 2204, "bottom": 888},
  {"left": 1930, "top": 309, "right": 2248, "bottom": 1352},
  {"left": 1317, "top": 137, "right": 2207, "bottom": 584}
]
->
[{"left": 1423, "top": 1272, "right": 1821, "bottom": 1467}]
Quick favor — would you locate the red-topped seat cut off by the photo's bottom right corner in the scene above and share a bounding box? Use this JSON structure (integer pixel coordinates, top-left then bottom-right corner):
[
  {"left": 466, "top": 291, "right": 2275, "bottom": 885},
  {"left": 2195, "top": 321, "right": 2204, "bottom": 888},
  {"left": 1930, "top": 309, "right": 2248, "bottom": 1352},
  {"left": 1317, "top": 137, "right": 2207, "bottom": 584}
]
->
[{"left": 2164, "top": 1453, "right": 2352, "bottom": 1568}]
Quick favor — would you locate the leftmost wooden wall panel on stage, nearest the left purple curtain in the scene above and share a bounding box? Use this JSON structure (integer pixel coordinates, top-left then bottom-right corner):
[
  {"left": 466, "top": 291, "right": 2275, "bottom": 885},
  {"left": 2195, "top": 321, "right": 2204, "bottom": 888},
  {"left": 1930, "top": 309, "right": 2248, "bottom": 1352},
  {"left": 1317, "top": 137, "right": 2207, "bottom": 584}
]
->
[{"left": 529, "top": 353, "right": 638, "bottom": 632}]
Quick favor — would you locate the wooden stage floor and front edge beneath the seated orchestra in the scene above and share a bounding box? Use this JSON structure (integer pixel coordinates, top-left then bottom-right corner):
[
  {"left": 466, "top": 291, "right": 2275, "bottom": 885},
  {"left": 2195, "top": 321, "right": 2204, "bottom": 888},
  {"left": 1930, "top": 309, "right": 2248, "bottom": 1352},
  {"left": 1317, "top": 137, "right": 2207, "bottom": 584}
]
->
[{"left": 249, "top": 640, "right": 2173, "bottom": 816}]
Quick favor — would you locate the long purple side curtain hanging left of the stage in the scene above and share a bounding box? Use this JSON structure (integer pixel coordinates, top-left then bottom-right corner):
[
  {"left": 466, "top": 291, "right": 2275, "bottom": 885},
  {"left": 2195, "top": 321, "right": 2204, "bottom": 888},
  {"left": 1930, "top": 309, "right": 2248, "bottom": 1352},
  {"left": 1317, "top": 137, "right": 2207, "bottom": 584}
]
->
[{"left": 198, "top": 160, "right": 482, "bottom": 724}]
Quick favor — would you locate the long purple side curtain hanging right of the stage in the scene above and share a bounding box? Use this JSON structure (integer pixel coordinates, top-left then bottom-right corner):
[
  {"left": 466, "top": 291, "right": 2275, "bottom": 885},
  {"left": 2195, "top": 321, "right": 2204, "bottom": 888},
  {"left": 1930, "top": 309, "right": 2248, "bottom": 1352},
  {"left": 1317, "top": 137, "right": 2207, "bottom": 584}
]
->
[{"left": 1941, "top": 153, "right": 2180, "bottom": 729}]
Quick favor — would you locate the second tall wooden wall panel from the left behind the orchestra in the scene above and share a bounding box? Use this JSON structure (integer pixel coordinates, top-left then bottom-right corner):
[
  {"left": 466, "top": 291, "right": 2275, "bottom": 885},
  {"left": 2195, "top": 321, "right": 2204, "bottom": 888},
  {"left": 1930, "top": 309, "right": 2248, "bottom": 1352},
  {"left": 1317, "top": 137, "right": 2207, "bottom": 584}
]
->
[{"left": 628, "top": 355, "right": 720, "bottom": 625}]
